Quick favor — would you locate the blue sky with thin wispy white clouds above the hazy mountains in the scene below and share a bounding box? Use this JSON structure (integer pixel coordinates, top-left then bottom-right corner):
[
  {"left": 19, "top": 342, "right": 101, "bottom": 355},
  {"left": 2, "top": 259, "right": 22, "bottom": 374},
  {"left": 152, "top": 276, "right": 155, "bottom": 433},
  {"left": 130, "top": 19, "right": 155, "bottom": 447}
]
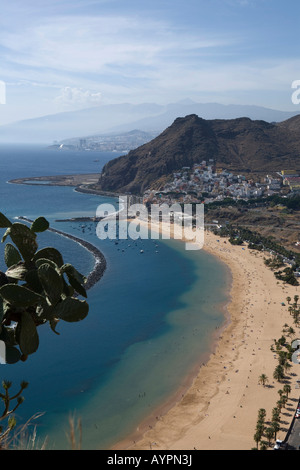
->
[{"left": 0, "top": 0, "right": 300, "bottom": 125}]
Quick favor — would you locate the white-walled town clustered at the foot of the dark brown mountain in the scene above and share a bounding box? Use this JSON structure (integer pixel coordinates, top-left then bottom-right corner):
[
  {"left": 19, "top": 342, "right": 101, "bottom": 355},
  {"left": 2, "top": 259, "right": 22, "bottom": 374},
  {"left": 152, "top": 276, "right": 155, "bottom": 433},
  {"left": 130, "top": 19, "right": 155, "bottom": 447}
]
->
[{"left": 143, "top": 159, "right": 300, "bottom": 203}]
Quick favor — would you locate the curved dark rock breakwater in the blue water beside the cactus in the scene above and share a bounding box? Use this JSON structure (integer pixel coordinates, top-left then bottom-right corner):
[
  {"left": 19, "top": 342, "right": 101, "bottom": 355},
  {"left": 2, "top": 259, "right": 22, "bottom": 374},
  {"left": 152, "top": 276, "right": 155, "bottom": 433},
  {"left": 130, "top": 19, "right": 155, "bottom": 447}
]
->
[{"left": 18, "top": 216, "right": 107, "bottom": 290}]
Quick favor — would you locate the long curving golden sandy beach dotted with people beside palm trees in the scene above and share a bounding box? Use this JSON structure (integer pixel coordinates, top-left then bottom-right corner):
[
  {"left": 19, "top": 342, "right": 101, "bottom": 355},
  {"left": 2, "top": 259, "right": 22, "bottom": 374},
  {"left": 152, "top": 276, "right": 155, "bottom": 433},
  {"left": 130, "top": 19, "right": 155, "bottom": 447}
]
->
[{"left": 115, "top": 220, "right": 300, "bottom": 450}]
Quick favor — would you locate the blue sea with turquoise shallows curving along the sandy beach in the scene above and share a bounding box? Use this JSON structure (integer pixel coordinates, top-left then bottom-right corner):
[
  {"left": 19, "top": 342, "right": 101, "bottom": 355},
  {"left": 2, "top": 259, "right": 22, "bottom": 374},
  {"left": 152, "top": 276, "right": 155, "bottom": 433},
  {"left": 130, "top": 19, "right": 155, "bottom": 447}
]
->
[{"left": 0, "top": 144, "right": 231, "bottom": 450}]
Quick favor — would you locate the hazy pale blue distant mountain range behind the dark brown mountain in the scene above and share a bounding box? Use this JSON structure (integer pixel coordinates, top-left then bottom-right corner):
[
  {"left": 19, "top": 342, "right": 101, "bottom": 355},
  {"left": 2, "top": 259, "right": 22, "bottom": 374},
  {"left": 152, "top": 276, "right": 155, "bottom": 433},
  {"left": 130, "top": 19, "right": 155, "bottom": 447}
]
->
[{"left": 0, "top": 100, "right": 297, "bottom": 145}]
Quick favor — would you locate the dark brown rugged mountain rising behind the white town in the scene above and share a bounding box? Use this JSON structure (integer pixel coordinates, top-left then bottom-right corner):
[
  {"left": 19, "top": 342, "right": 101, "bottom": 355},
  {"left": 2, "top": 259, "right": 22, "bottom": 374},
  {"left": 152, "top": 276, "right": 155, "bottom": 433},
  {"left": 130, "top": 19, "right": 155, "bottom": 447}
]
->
[{"left": 99, "top": 114, "right": 300, "bottom": 194}]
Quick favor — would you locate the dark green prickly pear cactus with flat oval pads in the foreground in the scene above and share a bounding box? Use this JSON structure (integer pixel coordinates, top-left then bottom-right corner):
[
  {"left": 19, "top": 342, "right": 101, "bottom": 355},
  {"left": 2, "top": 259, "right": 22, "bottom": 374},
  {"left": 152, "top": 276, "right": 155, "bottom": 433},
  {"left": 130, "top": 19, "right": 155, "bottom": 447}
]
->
[{"left": 0, "top": 212, "right": 89, "bottom": 363}]
